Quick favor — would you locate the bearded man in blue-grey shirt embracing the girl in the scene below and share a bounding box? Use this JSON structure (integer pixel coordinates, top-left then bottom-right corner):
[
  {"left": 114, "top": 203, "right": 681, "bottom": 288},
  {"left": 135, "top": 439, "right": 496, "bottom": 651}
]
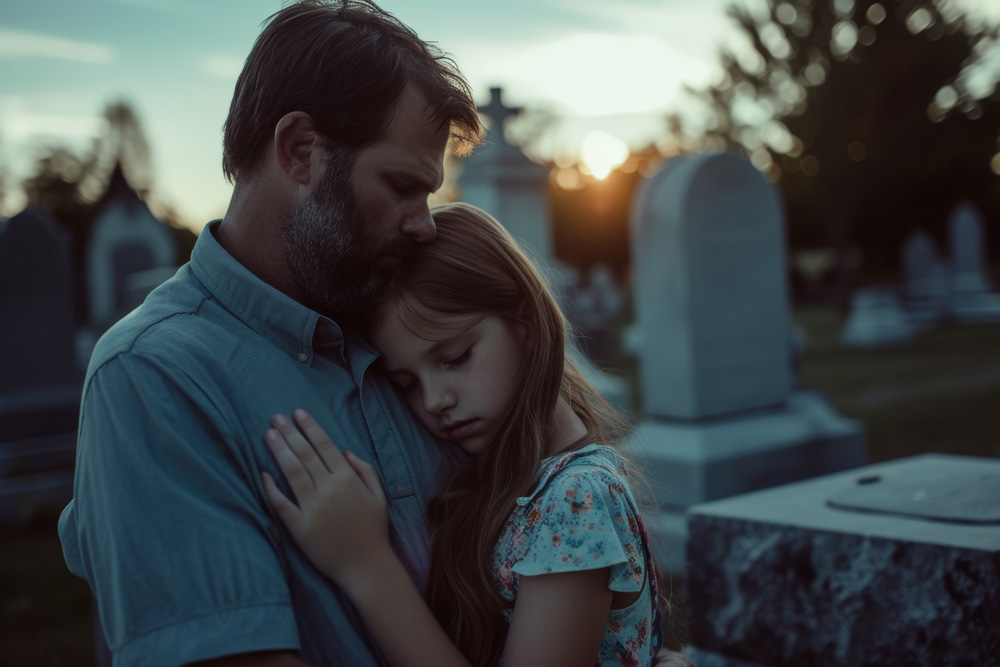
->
[{"left": 59, "top": 0, "right": 480, "bottom": 666}]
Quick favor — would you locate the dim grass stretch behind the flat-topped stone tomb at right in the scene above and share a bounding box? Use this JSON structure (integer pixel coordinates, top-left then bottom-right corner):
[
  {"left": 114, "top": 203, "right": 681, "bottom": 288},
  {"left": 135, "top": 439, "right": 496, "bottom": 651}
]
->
[{"left": 794, "top": 308, "right": 1000, "bottom": 462}]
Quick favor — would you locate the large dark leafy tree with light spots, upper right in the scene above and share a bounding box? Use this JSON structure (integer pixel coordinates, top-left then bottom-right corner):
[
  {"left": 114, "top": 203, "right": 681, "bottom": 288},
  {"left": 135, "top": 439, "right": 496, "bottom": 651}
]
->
[{"left": 688, "top": 0, "right": 1000, "bottom": 302}]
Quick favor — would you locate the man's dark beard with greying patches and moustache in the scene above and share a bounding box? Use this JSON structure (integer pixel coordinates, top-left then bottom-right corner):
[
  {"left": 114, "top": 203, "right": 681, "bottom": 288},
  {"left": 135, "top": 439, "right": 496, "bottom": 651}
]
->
[{"left": 281, "top": 148, "right": 412, "bottom": 317}]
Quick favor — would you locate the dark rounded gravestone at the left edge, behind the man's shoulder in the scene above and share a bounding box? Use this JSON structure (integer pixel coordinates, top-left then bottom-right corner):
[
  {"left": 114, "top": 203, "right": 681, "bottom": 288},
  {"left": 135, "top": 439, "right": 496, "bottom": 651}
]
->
[{"left": 0, "top": 210, "right": 83, "bottom": 524}]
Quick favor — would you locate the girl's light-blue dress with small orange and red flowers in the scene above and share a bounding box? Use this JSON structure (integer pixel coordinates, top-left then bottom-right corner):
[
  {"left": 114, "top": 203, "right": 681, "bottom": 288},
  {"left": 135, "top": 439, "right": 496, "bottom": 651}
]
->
[{"left": 493, "top": 445, "right": 662, "bottom": 667}]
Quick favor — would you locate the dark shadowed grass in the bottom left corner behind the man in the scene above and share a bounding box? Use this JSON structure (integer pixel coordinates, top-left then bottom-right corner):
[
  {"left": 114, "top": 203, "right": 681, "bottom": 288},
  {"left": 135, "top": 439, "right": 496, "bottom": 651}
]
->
[{"left": 0, "top": 508, "right": 94, "bottom": 667}]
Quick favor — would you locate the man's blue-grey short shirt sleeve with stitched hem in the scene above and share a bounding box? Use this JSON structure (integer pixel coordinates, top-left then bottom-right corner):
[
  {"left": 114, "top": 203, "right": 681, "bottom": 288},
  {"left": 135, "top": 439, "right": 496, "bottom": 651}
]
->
[{"left": 59, "top": 354, "right": 299, "bottom": 667}]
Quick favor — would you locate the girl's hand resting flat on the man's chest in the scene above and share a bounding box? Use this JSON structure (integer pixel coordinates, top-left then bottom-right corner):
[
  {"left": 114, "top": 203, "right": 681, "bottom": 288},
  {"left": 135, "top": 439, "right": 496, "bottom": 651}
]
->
[{"left": 261, "top": 410, "right": 395, "bottom": 589}]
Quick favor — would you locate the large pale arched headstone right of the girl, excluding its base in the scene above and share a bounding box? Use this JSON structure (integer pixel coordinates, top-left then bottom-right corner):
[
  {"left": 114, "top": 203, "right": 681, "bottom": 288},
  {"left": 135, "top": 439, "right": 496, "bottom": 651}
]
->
[{"left": 632, "top": 153, "right": 792, "bottom": 419}]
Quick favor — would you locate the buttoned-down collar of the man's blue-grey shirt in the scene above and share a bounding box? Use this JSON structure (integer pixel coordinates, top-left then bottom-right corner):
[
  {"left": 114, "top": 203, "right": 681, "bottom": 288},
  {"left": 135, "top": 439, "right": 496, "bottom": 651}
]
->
[{"left": 191, "top": 220, "right": 346, "bottom": 364}]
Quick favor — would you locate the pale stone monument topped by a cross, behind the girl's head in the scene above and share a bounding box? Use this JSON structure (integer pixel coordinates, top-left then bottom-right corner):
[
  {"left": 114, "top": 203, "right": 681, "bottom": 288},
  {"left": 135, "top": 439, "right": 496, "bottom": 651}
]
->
[{"left": 458, "top": 88, "right": 631, "bottom": 411}]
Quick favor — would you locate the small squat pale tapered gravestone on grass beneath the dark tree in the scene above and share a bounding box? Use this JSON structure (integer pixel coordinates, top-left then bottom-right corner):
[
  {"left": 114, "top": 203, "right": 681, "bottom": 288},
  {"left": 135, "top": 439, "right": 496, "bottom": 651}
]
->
[{"left": 840, "top": 286, "right": 913, "bottom": 349}]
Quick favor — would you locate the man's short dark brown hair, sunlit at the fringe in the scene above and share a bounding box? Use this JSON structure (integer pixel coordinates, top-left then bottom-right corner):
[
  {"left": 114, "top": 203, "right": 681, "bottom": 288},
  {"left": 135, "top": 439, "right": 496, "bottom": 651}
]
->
[{"left": 222, "top": 0, "right": 481, "bottom": 182}]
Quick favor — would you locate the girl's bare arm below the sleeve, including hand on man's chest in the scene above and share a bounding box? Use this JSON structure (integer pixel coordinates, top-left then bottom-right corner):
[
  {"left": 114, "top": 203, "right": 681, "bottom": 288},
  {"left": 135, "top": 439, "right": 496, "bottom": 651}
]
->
[{"left": 263, "top": 410, "right": 612, "bottom": 667}]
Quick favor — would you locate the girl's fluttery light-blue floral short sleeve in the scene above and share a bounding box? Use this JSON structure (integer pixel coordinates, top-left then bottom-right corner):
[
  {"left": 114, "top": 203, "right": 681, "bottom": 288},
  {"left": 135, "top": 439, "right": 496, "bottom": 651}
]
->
[{"left": 511, "top": 462, "right": 645, "bottom": 592}]
